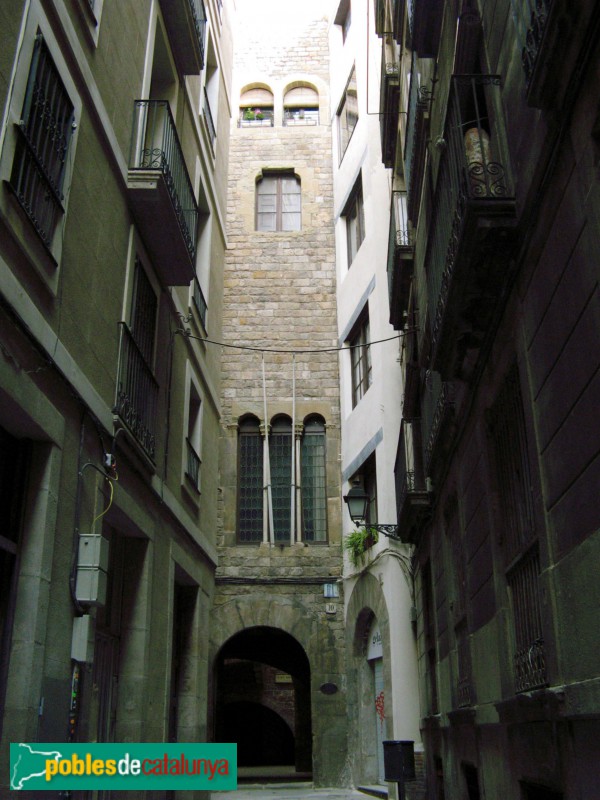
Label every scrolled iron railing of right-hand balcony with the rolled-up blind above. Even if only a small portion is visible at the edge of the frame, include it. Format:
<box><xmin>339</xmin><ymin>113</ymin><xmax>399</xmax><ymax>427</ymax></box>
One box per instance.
<box><xmin>425</xmin><ymin>75</ymin><xmax>514</xmax><ymax>356</ymax></box>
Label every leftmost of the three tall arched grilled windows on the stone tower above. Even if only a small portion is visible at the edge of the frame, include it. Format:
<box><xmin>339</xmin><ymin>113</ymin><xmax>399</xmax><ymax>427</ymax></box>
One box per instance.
<box><xmin>238</xmin><ymin>417</ymin><xmax>263</xmax><ymax>542</ymax></box>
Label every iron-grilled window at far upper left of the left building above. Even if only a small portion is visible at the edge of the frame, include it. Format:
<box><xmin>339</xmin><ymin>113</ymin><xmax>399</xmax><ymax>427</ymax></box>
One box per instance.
<box><xmin>9</xmin><ymin>31</ymin><xmax>75</xmax><ymax>248</ymax></box>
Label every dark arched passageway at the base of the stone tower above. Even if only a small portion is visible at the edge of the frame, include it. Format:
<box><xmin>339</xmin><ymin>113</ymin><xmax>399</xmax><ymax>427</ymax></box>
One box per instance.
<box><xmin>215</xmin><ymin>626</ymin><xmax>312</xmax><ymax>777</ymax></box>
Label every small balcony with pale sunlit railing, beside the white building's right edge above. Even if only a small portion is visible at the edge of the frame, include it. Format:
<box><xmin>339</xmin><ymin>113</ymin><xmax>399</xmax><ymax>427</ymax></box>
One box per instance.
<box><xmin>387</xmin><ymin>191</ymin><xmax>414</xmax><ymax>331</ymax></box>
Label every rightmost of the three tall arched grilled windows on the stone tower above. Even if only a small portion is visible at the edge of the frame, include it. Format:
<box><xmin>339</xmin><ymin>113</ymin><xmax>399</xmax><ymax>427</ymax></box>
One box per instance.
<box><xmin>301</xmin><ymin>417</ymin><xmax>327</xmax><ymax>542</ymax></box>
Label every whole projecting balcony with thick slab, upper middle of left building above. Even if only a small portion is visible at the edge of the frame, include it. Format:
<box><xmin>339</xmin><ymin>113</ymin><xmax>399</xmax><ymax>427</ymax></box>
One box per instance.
<box><xmin>127</xmin><ymin>100</ymin><xmax>198</xmax><ymax>286</ymax></box>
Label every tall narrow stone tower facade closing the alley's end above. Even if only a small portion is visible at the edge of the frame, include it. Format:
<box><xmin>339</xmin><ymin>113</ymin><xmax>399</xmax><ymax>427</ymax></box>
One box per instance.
<box><xmin>210</xmin><ymin>3</ymin><xmax>347</xmax><ymax>785</ymax></box>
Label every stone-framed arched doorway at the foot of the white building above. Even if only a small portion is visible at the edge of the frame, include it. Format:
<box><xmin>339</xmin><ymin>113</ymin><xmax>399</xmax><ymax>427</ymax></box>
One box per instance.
<box><xmin>346</xmin><ymin>572</ymin><xmax>394</xmax><ymax>785</ymax></box>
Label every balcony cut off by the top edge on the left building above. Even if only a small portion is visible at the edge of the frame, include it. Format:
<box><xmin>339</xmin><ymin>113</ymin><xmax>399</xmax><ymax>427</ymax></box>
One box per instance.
<box><xmin>160</xmin><ymin>0</ymin><xmax>206</xmax><ymax>75</ymax></box>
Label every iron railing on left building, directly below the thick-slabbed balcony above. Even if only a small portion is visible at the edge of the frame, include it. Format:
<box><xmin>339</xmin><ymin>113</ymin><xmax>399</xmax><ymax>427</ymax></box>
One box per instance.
<box><xmin>114</xmin><ymin>322</ymin><xmax>158</xmax><ymax>461</ymax></box>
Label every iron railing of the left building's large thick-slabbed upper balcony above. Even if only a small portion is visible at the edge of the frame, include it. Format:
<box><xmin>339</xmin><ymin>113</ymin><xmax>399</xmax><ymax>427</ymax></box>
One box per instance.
<box><xmin>129</xmin><ymin>100</ymin><xmax>198</xmax><ymax>259</ymax></box>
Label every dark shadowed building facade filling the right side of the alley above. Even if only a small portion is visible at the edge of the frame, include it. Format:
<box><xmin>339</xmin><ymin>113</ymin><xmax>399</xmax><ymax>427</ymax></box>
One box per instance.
<box><xmin>376</xmin><ymin>1</ymin><xmax>600</xmax><ymax>800</ymax></box>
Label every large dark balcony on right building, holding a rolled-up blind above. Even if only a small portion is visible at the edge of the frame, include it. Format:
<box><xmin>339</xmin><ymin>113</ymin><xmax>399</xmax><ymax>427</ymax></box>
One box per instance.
<box><xmin>424</xmin><ymin>75</ymin><xmax>516</xmax><ymax>379</ymax></box>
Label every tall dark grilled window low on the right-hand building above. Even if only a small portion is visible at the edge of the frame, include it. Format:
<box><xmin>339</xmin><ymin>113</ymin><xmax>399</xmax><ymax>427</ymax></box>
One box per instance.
<box><xmin>490</xmin><ymin>367</ymin><xmax>546</xmax><ymax>692</ymax></box>
